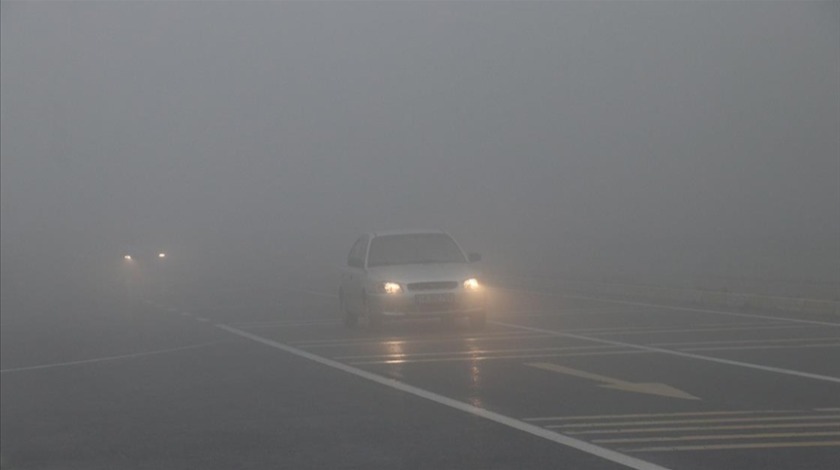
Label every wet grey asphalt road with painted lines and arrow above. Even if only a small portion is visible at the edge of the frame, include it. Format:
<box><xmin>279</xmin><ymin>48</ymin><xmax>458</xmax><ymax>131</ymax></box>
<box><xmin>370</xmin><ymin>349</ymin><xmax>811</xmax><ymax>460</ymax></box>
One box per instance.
<box><xmin>0</xmin><ymin>276</ymin><xmax>840</xmax><ymax>469</ymax></box>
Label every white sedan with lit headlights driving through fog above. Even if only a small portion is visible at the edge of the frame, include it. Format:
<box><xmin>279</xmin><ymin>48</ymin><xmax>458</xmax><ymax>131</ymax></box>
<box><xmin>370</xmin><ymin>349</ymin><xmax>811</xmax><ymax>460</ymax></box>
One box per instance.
<box><xmin>338</xmin><ymin>230</ymin><xmax>486</xmax><ymax>328</ymax></box>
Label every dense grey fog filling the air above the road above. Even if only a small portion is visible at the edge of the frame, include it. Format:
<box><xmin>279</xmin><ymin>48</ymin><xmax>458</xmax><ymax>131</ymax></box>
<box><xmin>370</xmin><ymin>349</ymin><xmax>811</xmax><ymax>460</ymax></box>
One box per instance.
<box><xmin>0</xmin><ymin>1</ymin><xmax>840</xmax><ymax>302</ymax></box>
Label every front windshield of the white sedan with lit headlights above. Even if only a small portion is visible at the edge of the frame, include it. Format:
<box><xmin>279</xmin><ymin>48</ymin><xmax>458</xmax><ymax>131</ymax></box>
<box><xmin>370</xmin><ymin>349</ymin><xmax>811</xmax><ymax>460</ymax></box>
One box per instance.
<box><xmin>368</xmin><ymin>233</ymin><xmax>466</xmax><ymax>266</ymax></box>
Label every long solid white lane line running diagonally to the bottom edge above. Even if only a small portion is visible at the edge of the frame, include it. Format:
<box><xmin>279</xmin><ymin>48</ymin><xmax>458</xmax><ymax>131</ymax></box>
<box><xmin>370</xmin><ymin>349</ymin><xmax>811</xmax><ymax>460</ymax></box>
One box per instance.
<box><xmin>216</xmin><ymin>324</ymin><xmax>667</xmax><ymax>470</ymax></box>
